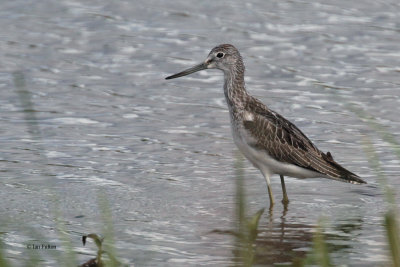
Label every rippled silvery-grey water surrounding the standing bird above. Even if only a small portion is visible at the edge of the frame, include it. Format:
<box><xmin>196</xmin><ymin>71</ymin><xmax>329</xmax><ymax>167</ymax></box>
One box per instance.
<box><xmin>0</xmin><ymin>0</ymin><xmax>400</xmax><ymax>266</ymax></box>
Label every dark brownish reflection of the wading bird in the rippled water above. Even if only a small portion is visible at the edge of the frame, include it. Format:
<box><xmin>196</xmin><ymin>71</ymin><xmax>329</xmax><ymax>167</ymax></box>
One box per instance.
<box><xmin>212</xmin><ymin>205</ymin><xmax>363</xmax><ymax>266</ymax></box>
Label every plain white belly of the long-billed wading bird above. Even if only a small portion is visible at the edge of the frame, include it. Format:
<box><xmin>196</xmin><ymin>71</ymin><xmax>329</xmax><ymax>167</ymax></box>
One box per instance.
<box><xmin>232</xmin><ymin>124</ymin><xmax>325</xmax><ymax>178</ymax></box>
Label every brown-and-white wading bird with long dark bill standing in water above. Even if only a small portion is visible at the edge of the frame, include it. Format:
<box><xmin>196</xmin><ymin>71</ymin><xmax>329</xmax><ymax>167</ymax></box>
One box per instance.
<box><xmin>165</xmin><ymin>44</ymin><xmax>366</xmax><ymax>207</ymax></box>
